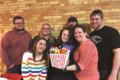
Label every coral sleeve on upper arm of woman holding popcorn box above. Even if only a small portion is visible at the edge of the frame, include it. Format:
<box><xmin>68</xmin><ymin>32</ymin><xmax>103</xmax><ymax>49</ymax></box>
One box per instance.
<box><xmin>78</xmin><ymin>43</ymin><xmax>96</xmax><ymax>70</ymax></box>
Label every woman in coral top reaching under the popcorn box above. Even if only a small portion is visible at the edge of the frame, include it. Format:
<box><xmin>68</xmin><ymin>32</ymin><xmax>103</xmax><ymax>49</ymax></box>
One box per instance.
<box><xmin>59</xmin><ymin>25</ymin><xmax>100</xmax><ymax>80</ymax></box>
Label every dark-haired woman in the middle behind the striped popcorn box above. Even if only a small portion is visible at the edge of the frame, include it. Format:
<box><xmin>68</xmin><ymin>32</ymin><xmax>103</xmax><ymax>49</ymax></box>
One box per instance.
<box><xmin>48</xmin><ymin>27</ymin><xmax>74</xmax><ymax>80</ymax></box>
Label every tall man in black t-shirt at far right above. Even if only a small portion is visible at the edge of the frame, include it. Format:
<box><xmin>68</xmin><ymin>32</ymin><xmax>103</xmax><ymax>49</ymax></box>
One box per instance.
<box><xmin>90</xmin><ymin>10</ymin><xmax>120</xmax><ymax>80</ymax></box>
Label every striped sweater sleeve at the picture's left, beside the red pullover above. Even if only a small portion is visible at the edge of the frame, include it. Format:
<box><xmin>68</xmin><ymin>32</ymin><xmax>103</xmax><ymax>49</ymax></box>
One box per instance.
<box><xmin>21</xmin><ymin>53</ymin><xmax>30</xmax><ymax>80</ymax></box>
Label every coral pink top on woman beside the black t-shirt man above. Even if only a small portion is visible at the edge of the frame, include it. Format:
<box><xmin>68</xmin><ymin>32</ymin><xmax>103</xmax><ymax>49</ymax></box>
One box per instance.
<box><xmin>74</xmin><ymin>39</ymin><xmax>100</xmax><ymax>80</ymax></box>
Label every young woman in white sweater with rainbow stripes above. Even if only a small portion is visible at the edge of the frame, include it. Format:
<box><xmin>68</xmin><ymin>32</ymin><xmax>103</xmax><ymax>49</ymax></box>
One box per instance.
<box><xmin>21</xmin><ymin>38</ymin><xmax>49</xmax><ymax>80</ymax></box>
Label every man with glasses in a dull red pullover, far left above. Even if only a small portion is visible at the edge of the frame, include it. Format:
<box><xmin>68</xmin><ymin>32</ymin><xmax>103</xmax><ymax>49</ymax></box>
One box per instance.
<box><xmin>1</xmin><ymin>16</ymin><xmax>32</xmax><ymax>74</ymax></box>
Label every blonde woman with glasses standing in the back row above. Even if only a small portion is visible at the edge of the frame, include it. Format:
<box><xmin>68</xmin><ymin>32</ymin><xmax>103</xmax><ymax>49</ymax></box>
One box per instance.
<box><xmin>29</xmin><ymin>23</ymin><xmax>56</xmax><ymax>49</ymax></box>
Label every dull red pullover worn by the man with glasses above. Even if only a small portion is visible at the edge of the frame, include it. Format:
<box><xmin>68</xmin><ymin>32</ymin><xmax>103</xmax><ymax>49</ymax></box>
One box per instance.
<box><xmin>0</xmin><ymin>29</ymin><xmax>32</xmax><ymax>67</ymax></box>
